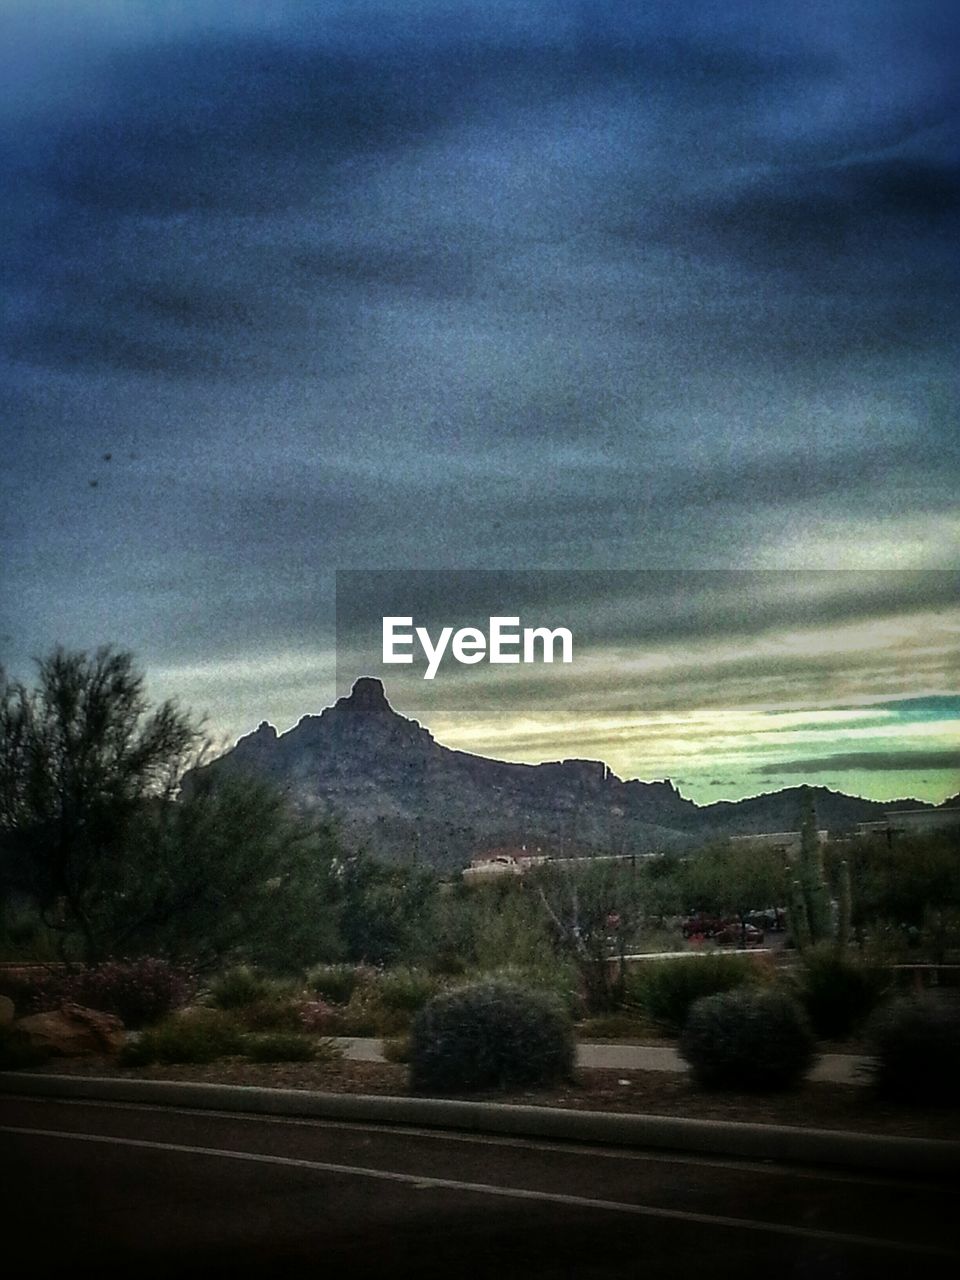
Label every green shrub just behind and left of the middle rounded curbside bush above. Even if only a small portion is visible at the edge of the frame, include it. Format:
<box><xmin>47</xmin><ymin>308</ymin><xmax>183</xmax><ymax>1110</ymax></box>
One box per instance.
<box><xmin>626</xmin><ymin>954</ymin><xmax>758</xmax><ymax>1036</ymax></box>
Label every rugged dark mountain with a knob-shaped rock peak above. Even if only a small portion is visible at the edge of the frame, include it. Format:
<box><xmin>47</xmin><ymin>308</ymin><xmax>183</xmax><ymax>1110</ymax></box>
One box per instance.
<box><xmin>192</xmin><ymin>677</ymin><xmax>916</xmax><ymax>868</ymax></box>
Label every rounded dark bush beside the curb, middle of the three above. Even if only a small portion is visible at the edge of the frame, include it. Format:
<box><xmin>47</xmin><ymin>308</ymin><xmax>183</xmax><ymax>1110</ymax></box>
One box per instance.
<box><xmin>680</xmin><ymin>988</ymin><xmax>815</xmax><ymax>1092</ymax></box>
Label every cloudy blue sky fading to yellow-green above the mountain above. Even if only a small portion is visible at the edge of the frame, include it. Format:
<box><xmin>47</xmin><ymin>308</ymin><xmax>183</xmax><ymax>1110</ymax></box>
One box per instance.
<box><xmin>0</xmin><ymin>0</ymin><xmax>960</xmax><ymax>801</ymax></box>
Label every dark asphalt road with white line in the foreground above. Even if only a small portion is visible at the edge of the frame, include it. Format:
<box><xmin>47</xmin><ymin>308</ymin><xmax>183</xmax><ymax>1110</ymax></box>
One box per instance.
<box><xmin>0</xmin><ymin>1097</ymin><xmax>960</xmax><ymax>1280</ymax></box>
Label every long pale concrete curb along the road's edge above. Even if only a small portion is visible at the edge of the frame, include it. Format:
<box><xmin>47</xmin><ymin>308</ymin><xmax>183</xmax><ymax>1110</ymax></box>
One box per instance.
<box><xmin>0</xmin><ymin>1071</ymin><xmax>960</xmax><ymax>1178</ymax></box>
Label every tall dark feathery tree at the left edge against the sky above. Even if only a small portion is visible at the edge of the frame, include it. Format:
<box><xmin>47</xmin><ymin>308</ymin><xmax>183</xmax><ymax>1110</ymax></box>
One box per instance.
<box><xmin>0</xmin><ymin>648</ymin><xmax>200</xmax><ymax>960</ymax></box>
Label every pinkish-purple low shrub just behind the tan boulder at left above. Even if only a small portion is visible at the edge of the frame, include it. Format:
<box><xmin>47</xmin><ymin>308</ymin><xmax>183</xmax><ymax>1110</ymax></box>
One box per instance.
<box><xmin>32</xmin><ymin>956</ymin><xmax>196</xmax><ymax>1028</ymax></box>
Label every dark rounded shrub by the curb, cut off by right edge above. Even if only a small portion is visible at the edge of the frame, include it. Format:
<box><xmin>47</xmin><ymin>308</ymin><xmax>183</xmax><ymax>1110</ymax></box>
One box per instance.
<box><xmin>868</xmin><ymin>997</ymin><xmax>960</xmax><ymax>1106</ymax></box>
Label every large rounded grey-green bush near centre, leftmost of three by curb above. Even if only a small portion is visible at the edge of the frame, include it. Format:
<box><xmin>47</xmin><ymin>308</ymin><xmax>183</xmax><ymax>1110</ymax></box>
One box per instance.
<box><xmin>410</xmin><ymin>982</ymin><xmax>573</xmax><ymax>1089</ymax></box>
